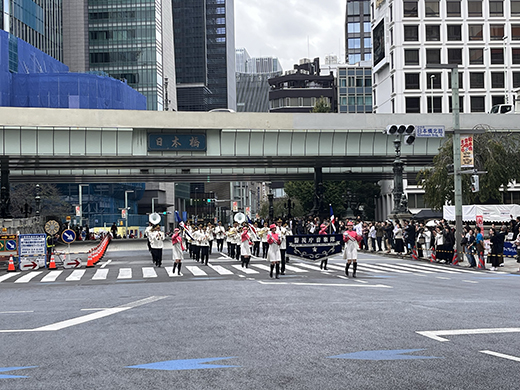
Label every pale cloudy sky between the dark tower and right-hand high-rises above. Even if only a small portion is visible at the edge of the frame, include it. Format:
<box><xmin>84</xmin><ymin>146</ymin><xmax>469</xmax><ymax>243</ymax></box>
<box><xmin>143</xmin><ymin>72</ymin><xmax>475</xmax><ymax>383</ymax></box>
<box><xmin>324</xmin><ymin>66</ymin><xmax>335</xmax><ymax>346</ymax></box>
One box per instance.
<box><xmin>235</xmin><ymin>0</ymin><xmax>346</xmax><ymax>70</ymax></box>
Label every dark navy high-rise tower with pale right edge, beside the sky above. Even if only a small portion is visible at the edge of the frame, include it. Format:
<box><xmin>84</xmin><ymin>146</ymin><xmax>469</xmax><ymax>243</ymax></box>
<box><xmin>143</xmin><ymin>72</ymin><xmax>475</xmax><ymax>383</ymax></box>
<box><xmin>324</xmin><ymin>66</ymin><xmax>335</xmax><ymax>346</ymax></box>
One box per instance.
<box><xmin>172</xmin><ymin>0</ymin><xmax>236</xmax><ymax>111</ymax></box>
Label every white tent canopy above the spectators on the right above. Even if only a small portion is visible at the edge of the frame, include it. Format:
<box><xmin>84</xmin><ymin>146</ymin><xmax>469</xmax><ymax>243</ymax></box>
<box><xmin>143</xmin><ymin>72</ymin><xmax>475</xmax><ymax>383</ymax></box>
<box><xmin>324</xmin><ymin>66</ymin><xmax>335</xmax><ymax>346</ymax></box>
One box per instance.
<box><xmin>443</xmin><ymin>204</ymin><xmax>520</xmax><ymax>222</ymax></box>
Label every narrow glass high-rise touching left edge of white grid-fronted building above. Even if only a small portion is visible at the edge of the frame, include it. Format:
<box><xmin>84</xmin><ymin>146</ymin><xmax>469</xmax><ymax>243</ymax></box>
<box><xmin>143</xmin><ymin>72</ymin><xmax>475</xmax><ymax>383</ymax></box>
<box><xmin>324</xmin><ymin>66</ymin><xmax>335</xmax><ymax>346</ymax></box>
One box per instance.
<box><xmin>345</xmin><ymin>0</ymin><xmax>372</xmax><ymax>65</ymax></box>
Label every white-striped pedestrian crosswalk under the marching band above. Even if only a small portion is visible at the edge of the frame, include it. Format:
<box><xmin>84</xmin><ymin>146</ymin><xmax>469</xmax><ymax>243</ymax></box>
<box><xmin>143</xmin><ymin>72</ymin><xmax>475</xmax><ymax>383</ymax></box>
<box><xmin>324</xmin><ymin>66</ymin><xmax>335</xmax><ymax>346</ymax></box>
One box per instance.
<box><xmin>0</xmin><ymin>260</ymin><xmax>492</xmax><ymax>284</ymax></box>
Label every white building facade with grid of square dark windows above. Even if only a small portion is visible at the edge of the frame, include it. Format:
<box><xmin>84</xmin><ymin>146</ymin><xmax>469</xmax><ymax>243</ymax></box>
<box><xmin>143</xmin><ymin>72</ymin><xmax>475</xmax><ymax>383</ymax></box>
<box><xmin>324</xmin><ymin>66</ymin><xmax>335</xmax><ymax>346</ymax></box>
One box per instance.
<box><xmin>371</xmin><ymin>0</ymin><xmax>520</xmax><ymax>113</ymax></box>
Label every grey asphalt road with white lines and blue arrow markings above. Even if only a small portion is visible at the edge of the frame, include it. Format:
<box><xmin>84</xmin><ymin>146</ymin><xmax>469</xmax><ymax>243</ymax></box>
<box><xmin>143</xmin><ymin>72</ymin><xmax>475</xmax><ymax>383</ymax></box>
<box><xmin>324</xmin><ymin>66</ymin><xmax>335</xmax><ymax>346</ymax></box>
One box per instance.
<box><xmin>0</xmin><ymin>242</ymin><xmax>520</xmax><ymax>390</ymax></box>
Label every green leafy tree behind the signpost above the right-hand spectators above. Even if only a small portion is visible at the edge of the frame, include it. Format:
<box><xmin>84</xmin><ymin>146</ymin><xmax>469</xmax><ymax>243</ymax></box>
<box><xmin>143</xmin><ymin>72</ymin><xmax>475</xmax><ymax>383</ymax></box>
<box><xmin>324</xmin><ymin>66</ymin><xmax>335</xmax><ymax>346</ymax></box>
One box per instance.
<box><xmin>417</xmin><ymin>131</ymin><xmax>520</xmax><ymax>210</ymax></box>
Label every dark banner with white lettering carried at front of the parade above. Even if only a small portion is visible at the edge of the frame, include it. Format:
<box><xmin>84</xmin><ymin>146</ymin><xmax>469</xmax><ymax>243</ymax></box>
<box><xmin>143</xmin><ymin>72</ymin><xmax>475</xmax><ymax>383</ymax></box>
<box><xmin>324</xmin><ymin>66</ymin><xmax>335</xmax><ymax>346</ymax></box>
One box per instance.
<box><xmin>286</xmin><ymin>234</ymin><xmax>343</xmax><ymax>261</ymax></box>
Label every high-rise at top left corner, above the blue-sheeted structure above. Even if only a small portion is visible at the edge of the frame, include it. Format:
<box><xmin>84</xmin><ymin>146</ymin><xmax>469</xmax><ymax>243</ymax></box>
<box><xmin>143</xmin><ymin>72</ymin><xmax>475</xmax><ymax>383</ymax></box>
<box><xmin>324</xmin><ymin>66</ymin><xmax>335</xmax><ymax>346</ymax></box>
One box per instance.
<box><xmin>0</xmin><ymin>0</ymin><xmax>63</xmax><ymax>61</ymax></box>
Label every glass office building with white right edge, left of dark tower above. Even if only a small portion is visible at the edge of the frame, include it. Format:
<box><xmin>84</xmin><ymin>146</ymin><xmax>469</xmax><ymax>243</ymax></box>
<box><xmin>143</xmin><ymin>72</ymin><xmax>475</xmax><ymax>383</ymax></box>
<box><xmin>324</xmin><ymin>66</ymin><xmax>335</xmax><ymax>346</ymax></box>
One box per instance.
<box><xmin>88</xmin><ymin>0</ymin><xmax>177</xmax><ymax>110</ymax></box>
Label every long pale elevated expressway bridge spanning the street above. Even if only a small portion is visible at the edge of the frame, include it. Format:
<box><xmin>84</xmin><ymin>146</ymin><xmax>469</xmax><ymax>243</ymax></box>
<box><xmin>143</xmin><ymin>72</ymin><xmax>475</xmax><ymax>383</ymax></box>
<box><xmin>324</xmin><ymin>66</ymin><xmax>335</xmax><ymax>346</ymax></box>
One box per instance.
<box><xmin>0</xmin><ymin>108</ymin><xmax>520</xmax><ymax>185</ymax></box>
